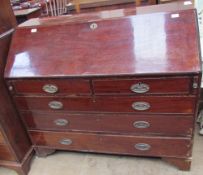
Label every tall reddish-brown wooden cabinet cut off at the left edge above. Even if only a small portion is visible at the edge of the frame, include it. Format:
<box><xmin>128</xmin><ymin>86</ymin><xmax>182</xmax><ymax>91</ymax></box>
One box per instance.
<box><xmin>0</xmin><ymin>0</ymin><xmax>32</xmax><ymax>175</ymax></box>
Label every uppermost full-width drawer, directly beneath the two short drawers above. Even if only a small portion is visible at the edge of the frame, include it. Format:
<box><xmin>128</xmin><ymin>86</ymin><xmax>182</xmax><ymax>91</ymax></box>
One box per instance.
<box><xmin>15</xmin><ymin>96</ymin><xmax>195</xmax><ymax>114</ymax></box>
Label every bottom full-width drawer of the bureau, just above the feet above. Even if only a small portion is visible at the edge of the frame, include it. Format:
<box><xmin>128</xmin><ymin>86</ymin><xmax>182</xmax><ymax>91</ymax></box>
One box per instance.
<box><xmin>29</xmin><ymin>131</ymin><xmax>192</xmax><ymax>157</ymax></box>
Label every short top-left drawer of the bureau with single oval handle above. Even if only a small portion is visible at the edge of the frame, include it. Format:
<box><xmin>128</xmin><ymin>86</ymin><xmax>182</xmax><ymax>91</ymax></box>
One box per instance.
<box><xmin>8</xmin><ymin>79</ymin><xmax>91</xmax><ymax>95</ymax></box>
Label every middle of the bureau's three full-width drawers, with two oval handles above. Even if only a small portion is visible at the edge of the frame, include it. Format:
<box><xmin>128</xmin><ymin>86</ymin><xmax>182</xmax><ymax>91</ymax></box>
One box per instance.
<box><xmin>21</xmin><ymin>112</ymin><xmax>193</xmax><ymax>136</ymax></box>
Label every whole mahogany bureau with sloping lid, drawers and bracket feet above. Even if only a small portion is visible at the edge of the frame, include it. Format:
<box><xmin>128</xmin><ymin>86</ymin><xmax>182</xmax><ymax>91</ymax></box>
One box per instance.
<box><xmin>5</xmin><ymin>1</ymin><xmax>201</xmax><ymax>170</ymax></box>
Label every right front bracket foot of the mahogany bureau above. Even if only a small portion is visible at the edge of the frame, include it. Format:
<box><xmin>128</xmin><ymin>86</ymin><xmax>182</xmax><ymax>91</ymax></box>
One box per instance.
<box><xmin>162</xmin><ymin>157</ymin><xmax>192</xmax><ymax>171</ymax></box>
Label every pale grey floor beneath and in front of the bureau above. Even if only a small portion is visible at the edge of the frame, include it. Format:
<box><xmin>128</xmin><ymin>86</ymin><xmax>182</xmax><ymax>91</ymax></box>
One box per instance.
<box><xmin>0</xmin><ymin>127</ymin><xmax>203</xmax><ymax>175</ymax></box>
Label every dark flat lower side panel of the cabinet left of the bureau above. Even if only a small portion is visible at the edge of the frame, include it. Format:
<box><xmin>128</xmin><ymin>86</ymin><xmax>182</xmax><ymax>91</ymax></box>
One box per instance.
<box><xmin>0</xmin><ymin>36</ymin><xmax>31</xmax><ymax>161</ymax></box>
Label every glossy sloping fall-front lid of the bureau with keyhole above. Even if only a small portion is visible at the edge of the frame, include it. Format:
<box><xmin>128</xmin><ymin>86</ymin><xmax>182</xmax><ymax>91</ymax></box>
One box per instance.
<box><xmin>5</xmin><ymin>5</ymin><xmax>201</xmax><ymax>78</ymax></box>
